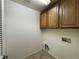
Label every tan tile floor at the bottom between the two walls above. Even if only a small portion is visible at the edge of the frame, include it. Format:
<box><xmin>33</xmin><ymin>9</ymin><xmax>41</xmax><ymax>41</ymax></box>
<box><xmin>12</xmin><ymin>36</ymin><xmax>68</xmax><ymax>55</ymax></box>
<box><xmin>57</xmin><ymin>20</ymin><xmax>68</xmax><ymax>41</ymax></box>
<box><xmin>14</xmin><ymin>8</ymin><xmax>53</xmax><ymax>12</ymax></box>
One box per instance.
<box><xmin>25</xmin><ymin>51</ymin><xmax>55</xmax><ymax>59</ymax></box>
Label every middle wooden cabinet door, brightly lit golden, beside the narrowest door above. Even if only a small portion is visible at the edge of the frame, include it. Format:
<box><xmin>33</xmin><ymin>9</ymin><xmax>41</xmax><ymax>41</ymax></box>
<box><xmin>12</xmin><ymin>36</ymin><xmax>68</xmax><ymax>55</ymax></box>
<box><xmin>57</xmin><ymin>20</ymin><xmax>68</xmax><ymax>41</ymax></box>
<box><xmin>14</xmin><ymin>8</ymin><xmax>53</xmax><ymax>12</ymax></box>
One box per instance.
<box><xmin>48</xmin><ymin>5</ymin><xmax>58</xmax><ymax>28</ymax></box>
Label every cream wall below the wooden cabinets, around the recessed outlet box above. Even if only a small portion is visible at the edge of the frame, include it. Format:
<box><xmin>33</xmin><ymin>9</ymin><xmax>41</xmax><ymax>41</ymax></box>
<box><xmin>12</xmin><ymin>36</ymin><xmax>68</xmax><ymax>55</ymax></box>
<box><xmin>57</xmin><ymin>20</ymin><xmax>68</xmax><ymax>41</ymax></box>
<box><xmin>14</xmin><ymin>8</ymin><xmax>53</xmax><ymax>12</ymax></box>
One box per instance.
<box><xmin>43</xmin><ymin>29</ymin><xmax>79</xmax><ymax>59</ymax></box>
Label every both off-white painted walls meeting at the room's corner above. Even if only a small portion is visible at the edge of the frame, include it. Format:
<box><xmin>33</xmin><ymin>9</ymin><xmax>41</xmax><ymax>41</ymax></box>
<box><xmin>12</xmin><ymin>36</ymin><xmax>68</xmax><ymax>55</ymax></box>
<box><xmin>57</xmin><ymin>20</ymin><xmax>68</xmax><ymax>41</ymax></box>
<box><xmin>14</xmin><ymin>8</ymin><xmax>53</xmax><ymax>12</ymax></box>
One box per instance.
<box><xmin>3</xmin><ymin>0</ymin><xmax>79</xmax><ymax>59</ymax></box>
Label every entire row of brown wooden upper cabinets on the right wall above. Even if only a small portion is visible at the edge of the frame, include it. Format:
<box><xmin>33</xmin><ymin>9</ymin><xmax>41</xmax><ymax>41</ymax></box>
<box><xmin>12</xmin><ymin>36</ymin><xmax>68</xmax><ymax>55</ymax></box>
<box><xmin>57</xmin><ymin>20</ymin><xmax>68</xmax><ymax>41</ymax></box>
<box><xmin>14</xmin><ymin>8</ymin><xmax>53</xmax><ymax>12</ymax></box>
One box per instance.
<box><xmin>41</xmin><ymin>0</ymin><xmax>79</xmax><ymax>28</ymax></box>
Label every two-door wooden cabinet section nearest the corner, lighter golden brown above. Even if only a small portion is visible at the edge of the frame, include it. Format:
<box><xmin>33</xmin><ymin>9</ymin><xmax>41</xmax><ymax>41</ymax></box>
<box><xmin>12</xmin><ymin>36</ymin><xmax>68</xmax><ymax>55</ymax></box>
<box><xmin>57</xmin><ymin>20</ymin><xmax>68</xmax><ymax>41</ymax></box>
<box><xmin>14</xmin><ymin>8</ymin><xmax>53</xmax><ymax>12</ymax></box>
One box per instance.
<box><xmin>40</xmin><ymin>5</ymin><xmax>58</xmax><ymax>28</ymax></box>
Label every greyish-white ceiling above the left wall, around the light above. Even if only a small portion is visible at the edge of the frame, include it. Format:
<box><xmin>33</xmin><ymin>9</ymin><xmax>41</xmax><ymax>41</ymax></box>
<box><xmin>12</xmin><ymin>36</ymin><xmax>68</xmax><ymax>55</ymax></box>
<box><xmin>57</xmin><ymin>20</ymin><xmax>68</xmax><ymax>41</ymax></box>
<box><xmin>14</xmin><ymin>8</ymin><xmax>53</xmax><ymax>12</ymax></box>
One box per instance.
<box><xmin>12</xmin><ymin>0</ymin><xmax>56</xmax><ymax>11</ymax></box>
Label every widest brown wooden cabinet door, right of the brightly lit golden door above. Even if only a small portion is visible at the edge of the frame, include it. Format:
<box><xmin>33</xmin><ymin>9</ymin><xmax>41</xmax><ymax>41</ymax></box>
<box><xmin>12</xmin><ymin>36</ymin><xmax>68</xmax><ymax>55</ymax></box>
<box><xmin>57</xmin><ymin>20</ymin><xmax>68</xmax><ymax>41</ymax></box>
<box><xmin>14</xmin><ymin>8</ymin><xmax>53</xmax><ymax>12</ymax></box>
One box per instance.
<box><xmin>60</xmin><ymin>0</ymin><xmax>76</xmax><ymax>27</ymax></box>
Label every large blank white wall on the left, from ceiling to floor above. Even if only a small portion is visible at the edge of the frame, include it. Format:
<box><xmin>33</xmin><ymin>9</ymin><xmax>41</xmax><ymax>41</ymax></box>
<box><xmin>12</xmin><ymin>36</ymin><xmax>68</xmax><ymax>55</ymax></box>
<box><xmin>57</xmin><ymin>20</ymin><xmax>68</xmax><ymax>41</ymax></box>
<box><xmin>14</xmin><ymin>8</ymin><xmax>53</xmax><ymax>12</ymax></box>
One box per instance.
<box><xmin>4</xmin><ymin>0</ymin><xmax>42</xmax><ymax>59</ymax></box>
